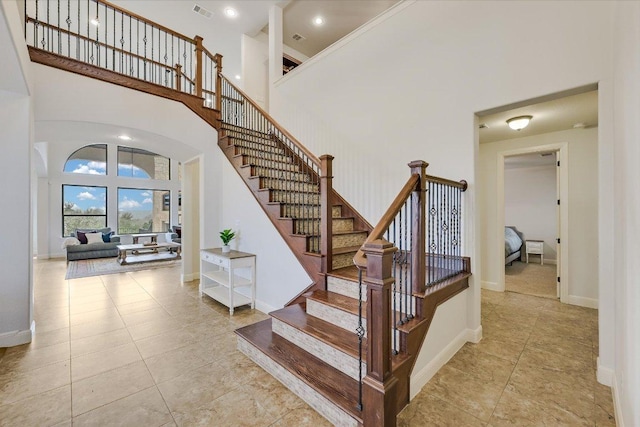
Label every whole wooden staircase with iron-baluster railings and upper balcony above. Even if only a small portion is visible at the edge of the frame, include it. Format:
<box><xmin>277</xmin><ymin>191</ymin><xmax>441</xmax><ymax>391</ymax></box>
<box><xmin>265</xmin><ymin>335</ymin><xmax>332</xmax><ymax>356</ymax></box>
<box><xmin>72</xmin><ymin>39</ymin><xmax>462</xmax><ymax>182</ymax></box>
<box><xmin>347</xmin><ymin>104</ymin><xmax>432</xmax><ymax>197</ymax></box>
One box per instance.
<box><xmin>25</xmin><ymin>0</ymin><xmax>470</xmax><ymax>426</ymax></box>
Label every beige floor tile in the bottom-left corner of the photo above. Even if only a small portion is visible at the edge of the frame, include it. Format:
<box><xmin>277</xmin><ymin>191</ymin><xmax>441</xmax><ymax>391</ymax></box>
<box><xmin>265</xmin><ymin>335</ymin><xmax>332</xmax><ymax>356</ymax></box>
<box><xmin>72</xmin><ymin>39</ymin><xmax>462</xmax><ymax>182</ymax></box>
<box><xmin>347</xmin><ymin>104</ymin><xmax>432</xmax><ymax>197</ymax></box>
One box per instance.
<box><xmin>0</xmin><ymin>385</ymin><xmax>71</xmax><ymax>427</ymax></box>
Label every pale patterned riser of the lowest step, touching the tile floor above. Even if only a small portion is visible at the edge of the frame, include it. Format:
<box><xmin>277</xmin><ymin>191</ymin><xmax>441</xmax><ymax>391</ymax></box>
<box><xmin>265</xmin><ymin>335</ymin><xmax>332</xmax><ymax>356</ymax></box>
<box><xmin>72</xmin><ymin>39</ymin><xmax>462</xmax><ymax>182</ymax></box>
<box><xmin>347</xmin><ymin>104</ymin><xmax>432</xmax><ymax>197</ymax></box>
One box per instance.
<box><xmin>238</xmin><ymin>337</ymin><xmax>358</xmax><ymax>427</ymax></box>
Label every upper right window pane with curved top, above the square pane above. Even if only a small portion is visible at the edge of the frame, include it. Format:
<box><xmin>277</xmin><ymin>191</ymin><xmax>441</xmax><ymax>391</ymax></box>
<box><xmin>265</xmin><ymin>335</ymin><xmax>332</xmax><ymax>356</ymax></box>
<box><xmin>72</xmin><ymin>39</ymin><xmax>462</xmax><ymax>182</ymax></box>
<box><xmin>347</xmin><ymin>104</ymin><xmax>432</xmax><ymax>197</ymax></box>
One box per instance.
<box><xmin>118</xmin><ymin>147</ymin><xmax>170</xmax><ymax>180</ymax></box>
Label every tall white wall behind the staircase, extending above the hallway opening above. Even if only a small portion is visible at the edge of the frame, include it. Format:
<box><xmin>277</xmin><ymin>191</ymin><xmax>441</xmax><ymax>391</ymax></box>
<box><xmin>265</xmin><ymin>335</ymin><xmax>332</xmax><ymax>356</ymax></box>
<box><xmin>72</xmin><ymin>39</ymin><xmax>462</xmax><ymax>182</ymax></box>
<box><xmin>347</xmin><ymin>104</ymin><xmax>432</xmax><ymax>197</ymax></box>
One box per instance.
<box><xmin>270</xmin><ymin>1</ymin><xmax>614</xmax><ymax>392</ymax></box>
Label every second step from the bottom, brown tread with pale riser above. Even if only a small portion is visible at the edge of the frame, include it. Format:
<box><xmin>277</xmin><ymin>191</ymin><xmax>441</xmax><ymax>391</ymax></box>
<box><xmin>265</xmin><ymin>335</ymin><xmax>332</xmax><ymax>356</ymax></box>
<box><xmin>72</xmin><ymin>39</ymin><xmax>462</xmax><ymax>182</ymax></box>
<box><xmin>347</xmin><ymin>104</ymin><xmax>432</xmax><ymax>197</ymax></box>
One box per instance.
<box><xmin>269</xmin><ymin>304</ymin><xmax>367</xmax><ymax>380</ymax></box>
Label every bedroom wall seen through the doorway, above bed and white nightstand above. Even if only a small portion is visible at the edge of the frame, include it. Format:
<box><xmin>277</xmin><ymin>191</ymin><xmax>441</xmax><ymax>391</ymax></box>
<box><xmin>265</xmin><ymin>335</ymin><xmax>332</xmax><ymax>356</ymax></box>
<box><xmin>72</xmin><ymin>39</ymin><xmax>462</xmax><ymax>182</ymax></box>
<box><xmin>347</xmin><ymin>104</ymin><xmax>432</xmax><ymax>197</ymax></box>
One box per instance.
<box><xmin>504</xmin><ymin>165</ymin><xmax>558</xmax><ymax>264</ymax></box>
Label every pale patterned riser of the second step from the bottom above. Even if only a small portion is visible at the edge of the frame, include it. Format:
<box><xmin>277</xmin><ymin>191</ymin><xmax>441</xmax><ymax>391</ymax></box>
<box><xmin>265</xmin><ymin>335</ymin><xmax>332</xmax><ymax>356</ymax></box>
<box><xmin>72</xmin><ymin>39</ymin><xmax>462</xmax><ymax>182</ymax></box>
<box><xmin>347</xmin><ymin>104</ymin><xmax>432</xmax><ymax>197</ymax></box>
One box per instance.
<box><xmin>272</xmin><ymin>318</ymin><xmax>367</xmax><ymax>380</ymax></box>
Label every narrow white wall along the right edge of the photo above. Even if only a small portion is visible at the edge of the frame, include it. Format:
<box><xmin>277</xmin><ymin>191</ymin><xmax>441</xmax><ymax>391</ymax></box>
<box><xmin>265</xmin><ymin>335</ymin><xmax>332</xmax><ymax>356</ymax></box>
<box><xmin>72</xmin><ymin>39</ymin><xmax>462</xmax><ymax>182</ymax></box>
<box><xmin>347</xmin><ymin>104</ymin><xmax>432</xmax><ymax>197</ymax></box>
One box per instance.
<box><xmin>598</xmin><ymin>2</ymin><xmax>640</xmax><ymax>427</ymax></box>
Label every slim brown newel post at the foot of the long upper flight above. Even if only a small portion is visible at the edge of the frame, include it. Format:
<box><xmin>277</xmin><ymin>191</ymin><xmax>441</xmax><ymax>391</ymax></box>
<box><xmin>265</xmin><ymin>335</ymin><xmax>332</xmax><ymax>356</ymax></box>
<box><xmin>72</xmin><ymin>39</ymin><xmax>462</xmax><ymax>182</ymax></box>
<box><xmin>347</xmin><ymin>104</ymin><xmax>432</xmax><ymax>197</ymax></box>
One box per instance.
<box><xmin>320</xmin><ymin>154</ymin><xmax>334</xmax><ymax>273</ymax></box>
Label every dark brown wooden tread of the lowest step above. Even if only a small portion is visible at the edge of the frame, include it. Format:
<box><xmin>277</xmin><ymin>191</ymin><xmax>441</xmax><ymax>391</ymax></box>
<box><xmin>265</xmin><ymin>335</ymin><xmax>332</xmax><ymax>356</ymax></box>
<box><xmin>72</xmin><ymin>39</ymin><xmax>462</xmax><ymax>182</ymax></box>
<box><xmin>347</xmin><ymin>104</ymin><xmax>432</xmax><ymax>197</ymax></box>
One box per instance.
<box><xmin>235</xmin><ymin>319</ymin><xmax>362</xmax><ymax>423</ymax></box>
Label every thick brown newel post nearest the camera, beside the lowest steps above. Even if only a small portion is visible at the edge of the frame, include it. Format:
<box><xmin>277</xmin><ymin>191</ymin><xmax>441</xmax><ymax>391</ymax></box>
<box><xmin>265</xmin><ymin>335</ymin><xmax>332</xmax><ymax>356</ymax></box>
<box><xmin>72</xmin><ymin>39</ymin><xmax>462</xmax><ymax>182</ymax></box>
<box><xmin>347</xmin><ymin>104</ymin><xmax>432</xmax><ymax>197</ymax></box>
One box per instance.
<box><xmin>362</xmin><ymin>239</ymin><xmax>398</xmax><ymax>427</ymax></box>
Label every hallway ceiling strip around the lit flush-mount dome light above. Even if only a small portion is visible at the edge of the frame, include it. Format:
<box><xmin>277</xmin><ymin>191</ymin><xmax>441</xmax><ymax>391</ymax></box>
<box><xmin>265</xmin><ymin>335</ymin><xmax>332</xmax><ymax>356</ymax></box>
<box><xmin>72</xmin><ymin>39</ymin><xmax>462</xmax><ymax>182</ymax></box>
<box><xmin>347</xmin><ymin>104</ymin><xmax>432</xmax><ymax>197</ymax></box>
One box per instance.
<box><xmin>478</xmin><ymin>90</ymin><xmax>598</xmax><ymax>144</ymax></box>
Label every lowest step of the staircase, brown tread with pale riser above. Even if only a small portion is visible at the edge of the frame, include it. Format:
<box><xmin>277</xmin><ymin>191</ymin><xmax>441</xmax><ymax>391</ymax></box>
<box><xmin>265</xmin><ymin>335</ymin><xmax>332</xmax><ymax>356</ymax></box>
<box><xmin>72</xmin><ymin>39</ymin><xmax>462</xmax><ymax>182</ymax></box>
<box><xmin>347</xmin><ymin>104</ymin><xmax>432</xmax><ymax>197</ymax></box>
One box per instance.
<box><xmin>236</xmin><ymin>319</ymin><xmax>363</xmax><ymax>427</ymax></box>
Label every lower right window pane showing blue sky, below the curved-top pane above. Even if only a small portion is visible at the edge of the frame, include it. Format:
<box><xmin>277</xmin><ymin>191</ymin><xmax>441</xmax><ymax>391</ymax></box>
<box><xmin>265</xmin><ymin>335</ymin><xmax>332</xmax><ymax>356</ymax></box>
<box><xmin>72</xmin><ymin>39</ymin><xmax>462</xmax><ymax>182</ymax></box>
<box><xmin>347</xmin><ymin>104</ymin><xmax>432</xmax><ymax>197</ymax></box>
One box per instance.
<box><xmin>118</xmin><ymin>188</ymin><xmax>171</xmax><ymax>234</ymax></box>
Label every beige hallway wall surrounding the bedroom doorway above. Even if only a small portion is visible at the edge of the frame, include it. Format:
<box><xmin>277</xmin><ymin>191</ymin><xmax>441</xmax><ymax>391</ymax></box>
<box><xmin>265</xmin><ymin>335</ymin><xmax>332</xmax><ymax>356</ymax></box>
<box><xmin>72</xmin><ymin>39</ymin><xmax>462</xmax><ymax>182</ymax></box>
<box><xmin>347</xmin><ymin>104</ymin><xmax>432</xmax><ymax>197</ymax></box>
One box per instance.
<box><xmin>479</xmin><ymin>129</ymin><xmax>598</xmax><ymax>307</ymax></box>
